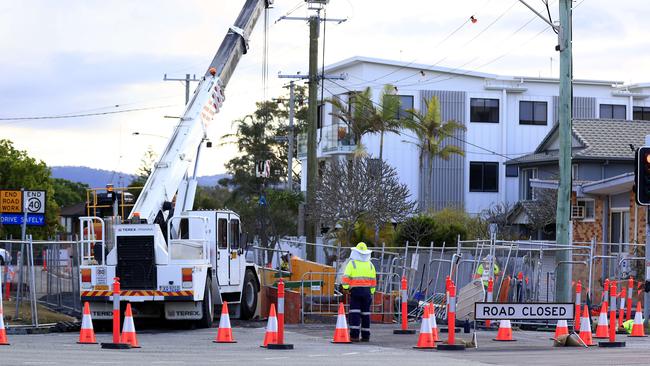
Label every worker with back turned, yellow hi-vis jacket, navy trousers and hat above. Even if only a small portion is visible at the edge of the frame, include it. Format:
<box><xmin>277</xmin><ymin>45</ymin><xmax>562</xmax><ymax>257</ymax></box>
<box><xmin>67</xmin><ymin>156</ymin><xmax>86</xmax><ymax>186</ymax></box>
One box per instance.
<box><xmin>341</xmin><ymin>243</ymin><xmax>377</xmax><ymax>342</ymax></box>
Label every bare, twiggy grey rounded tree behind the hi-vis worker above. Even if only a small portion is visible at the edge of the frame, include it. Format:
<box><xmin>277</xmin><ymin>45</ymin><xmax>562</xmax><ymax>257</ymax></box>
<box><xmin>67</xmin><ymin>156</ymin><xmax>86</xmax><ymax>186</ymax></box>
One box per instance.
<box><xmin>311</xmin><ymin>158</ymin><xmax>415</xmax><ymax>245</ymax></box>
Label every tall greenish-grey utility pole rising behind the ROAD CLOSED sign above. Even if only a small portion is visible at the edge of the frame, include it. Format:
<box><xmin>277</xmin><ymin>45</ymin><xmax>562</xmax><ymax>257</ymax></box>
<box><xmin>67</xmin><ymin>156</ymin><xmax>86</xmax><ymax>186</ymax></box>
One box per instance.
<box><xmin>519</xmin><ymin>0</ymin><xmax>573</xmax><ymax>302</ymax></box>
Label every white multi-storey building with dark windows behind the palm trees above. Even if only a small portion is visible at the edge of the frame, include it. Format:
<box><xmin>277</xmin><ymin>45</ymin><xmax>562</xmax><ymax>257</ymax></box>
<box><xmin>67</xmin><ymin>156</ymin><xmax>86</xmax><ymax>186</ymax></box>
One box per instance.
<box><xmin>298</xmin><ymin>57</ymin><xmax>650</xmax><ymax>214</ymax></box>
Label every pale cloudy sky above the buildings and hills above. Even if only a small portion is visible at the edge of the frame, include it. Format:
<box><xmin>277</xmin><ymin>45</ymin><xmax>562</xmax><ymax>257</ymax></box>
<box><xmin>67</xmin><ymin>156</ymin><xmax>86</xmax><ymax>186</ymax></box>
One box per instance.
<box><xmin>0</xmin><ymin>0</ymin><xmax>650</xmax><ymax>180</ymax></box>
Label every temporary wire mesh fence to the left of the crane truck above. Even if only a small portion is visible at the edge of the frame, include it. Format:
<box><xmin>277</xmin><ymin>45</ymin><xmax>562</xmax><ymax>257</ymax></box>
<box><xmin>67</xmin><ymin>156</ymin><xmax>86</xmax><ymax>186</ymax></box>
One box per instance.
<box><xmin>0</xmin><ymin>239</ymin><xmax>81</xmax><ymax>327</ymax></box>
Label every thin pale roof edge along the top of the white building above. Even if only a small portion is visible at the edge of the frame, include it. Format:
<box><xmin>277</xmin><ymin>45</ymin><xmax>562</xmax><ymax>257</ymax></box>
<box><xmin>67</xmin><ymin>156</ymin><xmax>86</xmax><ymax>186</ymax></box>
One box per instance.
<box><xmin>325</xmin><ymin>56</ymin><xmax>623</xmax><ymax>86</ymax></box>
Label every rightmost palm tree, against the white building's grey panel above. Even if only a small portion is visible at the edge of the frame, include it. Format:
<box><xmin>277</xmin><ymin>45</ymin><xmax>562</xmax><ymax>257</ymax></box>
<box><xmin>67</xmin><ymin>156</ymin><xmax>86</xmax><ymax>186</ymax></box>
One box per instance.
<box><xmin>403</xmin><ymin>97</ymin><xmax>465</xmax><ymax>210</ymax></box>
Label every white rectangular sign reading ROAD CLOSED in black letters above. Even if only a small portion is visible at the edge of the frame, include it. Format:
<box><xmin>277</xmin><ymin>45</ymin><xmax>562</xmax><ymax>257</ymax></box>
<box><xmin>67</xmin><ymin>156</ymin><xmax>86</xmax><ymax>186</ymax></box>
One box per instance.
<box><xmin>474</xmin><ymin>302</ymin><xmax>575</xmax><ymax>320</ymax></box>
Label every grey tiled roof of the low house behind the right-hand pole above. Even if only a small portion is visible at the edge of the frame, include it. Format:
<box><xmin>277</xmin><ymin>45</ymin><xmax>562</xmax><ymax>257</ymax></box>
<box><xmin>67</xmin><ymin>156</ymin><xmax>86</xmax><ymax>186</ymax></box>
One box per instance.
<box><xmin>506</xmin><ymin>119</ymin><xmax>650</xmax><ymax>165</ymax></box>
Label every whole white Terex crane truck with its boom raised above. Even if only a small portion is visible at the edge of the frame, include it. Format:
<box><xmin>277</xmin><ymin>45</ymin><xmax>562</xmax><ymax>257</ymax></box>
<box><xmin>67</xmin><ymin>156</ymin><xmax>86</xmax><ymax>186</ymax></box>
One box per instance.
<box><xmin>79</xmin><ymin>0</ymin><xmax>273</xmax><ymax>327</ymax></box>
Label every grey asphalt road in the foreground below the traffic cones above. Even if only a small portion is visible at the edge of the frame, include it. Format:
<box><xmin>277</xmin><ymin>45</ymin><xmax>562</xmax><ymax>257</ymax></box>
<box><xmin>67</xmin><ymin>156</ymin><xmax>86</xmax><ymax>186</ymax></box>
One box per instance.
<box><xmin>0</xmin><ymin>322</ymin><xmax>650</xmax><ymax>366</ymax></box>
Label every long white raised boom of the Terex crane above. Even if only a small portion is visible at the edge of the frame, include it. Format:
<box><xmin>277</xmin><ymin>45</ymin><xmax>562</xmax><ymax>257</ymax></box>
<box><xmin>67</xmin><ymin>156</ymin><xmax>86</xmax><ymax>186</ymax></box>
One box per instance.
<box><xmin>129</xmin><ymin>0</ymin><xmax>273</xmax><ymax>223</ymax></box>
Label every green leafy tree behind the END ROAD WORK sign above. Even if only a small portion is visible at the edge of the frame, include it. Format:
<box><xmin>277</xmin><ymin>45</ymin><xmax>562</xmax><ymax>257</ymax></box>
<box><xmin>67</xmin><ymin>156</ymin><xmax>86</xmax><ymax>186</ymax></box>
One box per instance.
<box><xmin>0</xmin><ymin>140</ymin><xmax>59</xmax><ymax>238</ymax></box>
